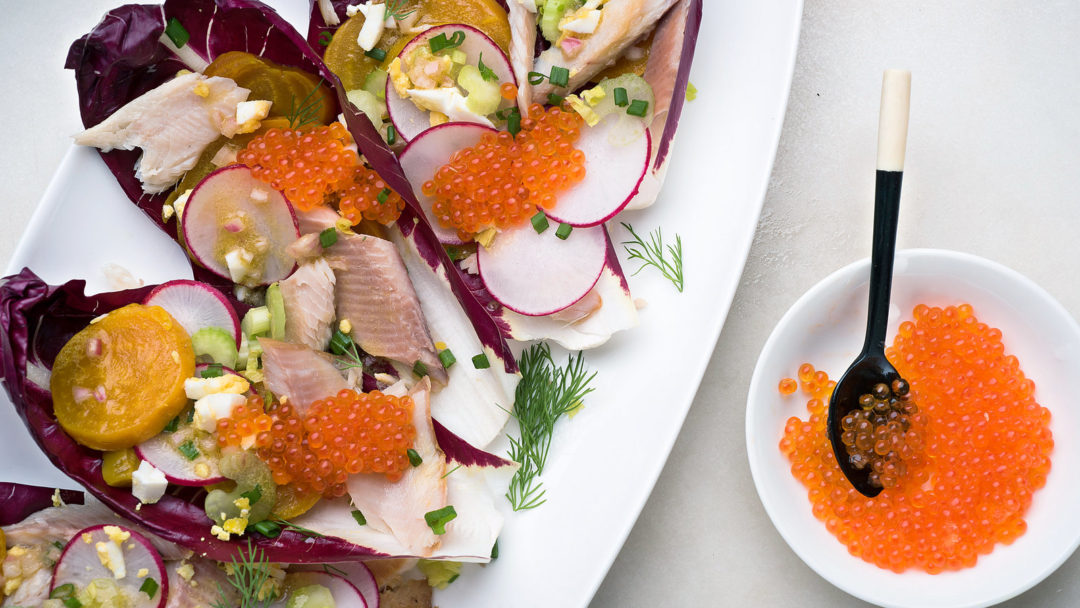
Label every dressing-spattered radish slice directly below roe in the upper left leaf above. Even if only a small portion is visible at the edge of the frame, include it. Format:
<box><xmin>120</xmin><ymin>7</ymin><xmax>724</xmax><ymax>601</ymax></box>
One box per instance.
<box><xmin>183</xmin><ymin>165</ymin><xmax>300</xmax><ymax>286</ymax></box>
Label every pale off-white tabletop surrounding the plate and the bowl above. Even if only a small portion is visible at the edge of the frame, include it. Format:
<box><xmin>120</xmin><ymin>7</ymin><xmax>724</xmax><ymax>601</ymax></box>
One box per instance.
<box><xmin>0</xmin><ymin>0</ymin><xmax>1080</xmax><ymax>608</ymax></box>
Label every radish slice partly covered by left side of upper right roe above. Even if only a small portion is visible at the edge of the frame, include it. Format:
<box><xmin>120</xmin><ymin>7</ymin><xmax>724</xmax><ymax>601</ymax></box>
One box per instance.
<box><xmin>401</xmin><ymin>122</ymin><xmax>498</xmax><ymax>245</ymax></box>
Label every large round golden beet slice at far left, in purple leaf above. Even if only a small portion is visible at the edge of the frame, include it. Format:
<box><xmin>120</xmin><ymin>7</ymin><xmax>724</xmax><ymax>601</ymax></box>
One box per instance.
<box><xmin>50</xmin><ymin>305</ymin><xmax>195</xmax><ymax>450</ymax></box>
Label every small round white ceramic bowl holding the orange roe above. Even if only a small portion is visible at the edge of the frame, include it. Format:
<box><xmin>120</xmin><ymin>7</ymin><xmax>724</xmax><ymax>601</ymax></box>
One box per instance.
<box><xmin>746</xmin><ymin>249</ymin><xmax>1080</xmax><ymax>608</ymax></box>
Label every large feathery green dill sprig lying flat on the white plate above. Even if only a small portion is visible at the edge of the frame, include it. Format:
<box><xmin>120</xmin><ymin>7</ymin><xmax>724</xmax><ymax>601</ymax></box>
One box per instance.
<box><xmin>507</xmin><ymin>342</ymin><xmax>596</xmax><ymax>511</ymax></box>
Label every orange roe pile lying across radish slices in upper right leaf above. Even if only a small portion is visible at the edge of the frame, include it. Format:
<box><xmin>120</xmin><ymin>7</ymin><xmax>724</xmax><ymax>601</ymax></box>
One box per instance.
<box><xmin>421</xmin><ymin>104</ymin><xmax>585</xmax><ymax>240</ymax></box>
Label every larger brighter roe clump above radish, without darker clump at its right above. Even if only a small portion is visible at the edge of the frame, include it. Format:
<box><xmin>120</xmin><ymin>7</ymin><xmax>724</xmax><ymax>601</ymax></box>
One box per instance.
<box><xmin>237</xmin><ymin>122</ymin><xmax>359</xmax><ymax>211</ymax></box>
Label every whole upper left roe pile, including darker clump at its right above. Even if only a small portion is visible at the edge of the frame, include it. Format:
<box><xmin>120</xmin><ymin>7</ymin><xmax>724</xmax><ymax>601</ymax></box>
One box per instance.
<box><xmin>237</xmin><ymin>122</ymin><xmax>405</xmax><ymax>226</ymax></box>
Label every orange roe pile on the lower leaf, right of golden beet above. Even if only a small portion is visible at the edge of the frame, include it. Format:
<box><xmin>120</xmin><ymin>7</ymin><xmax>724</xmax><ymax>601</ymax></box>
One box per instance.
<box><xmin>217</xmin><ymin>390</ymin><xmax>416</xmax><ymax>498</ymax></box>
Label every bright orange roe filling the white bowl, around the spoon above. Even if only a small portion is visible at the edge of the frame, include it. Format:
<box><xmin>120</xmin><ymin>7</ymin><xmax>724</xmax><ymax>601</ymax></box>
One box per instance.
<box><xmin>780</xmin><ymin>305</ymin><xmax>1054</xmax><ymax>573</ymax></box>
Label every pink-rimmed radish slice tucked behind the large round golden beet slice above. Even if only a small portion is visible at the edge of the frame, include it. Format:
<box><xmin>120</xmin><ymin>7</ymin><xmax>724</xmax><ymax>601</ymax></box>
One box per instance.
<box><xmin>143</xmin><ymin>279</ymin><xmax>240</xmax><ymax>348</ymax></box>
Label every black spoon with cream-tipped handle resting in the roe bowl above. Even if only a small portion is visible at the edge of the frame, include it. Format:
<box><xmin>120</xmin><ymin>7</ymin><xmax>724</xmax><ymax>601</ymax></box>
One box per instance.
<box><xmin>828</xmin><ymin>70</ymin><xmax>912</xmax><ymax>497</ymax></box>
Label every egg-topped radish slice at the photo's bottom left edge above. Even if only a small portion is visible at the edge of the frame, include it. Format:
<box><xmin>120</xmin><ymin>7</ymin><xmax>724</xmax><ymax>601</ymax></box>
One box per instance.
<box><xmin>50</xmin><ymin>525</ymin><xmax>168</xmax><ymax>608</ymax></box>
